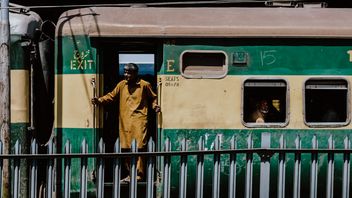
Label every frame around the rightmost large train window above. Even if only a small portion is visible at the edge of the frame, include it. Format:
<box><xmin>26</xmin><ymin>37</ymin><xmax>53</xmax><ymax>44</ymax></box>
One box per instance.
<box><xmin>302</xmin><ymin>77</ymin><xmax>351</xmax><ymax>128</ymax></box>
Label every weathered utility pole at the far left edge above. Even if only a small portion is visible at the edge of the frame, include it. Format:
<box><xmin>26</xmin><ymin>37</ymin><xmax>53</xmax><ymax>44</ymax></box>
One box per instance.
<box><xmin>0</xmin><ymin>0</ymin><xmax>11</xmax><ymax>197</ymax></box>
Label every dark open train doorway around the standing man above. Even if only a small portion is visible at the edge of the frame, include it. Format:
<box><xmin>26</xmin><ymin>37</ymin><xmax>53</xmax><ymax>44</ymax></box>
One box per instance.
<box><xmin>99</xmin><ymin>41</ymin><xmax>157</xmax><ymax>189</ymax></box>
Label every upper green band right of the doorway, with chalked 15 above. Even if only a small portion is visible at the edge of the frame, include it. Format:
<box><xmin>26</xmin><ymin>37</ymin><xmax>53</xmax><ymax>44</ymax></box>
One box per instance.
<box><xmin>160</xmin><ymin>39</ymin><xmax>352</xmax><ymax>75</ymax></box>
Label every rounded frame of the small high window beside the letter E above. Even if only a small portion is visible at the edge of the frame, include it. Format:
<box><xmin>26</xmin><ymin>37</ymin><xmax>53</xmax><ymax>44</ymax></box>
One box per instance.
<box><xmin>179</xmin><ymin>50</ymin><xmax>229</xmax><ymax>79</ymax></box>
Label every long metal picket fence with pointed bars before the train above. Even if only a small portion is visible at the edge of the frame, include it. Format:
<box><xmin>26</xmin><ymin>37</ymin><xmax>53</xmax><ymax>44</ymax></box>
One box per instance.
<box><xmin>0</xmin><ymin>133</ymin><xmax>351</xmax><ymax>198</ymax></box>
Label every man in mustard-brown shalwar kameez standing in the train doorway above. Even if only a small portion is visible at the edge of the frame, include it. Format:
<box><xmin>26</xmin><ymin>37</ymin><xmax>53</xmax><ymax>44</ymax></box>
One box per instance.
<box><xmin>92</xmin><ymin>63</ymin><xmax>160</xmax><ymax>182</ymax></box>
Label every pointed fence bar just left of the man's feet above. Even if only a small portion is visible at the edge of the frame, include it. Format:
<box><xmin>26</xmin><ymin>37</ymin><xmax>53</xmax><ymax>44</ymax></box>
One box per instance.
<box><xmin>113</xmin><ymin>138</ymin><xmax>121</xmax><ymax>198</ymax></box>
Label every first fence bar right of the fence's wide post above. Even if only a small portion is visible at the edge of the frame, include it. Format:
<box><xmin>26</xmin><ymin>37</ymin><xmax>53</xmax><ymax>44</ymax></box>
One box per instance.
<box><xmin>277</xmin><ymin>135</ymin><xmax>286</xmax><ymax>198</ymax></box>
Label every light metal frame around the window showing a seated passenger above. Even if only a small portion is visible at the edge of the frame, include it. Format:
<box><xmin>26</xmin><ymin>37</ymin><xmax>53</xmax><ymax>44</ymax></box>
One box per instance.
<box><xmin>241</xmin><ymin>77</ymin><xmax>290</xmax><ymax>128</ymax></box>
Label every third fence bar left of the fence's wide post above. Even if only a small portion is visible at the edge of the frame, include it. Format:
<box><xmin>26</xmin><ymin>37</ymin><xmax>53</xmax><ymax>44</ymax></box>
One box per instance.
<box><xmin>212</xmin><ymin>135</ymin><xmax>221</xmax><ymax>198</ymax></box>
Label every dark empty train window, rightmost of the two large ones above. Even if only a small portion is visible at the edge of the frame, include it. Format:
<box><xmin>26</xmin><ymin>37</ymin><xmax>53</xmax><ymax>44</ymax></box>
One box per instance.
<box><xmin>304</xmin><ymin>79</ymin><xmax>349</xmax><ymax>127</ymax></box>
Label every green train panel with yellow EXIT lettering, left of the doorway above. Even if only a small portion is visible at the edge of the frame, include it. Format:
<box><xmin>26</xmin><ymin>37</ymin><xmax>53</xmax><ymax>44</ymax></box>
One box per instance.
<box><xmin>55</xmin><ymin>35</ymin><xmax>97</xmax><ymax>74</ymax></box>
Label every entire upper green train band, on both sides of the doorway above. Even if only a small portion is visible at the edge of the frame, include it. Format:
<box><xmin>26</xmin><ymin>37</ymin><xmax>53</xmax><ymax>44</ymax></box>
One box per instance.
<box><xmin>55</xmin><ymin>35</ymin><xmax>352</xmax><ymax>75</ymax></box>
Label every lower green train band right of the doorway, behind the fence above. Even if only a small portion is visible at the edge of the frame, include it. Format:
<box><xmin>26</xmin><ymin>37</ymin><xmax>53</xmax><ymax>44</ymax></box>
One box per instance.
<box><xmin>159</xmin><ymin>129</ymin><xmax>351</xmax><ymax>197</ymax></box>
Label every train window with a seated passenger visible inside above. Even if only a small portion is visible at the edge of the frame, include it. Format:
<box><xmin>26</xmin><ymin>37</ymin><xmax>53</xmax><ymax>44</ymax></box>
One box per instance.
<box><xmin>242</xmin><ymin>79</ymin><xmax>289</xmax><ymax>127</ymax></box>
